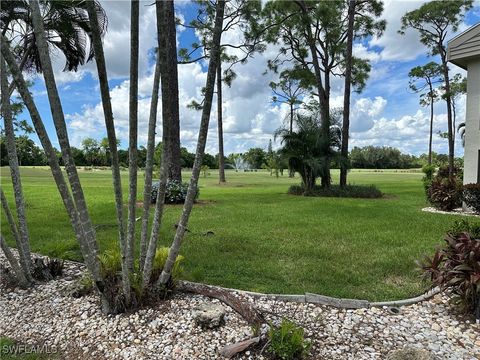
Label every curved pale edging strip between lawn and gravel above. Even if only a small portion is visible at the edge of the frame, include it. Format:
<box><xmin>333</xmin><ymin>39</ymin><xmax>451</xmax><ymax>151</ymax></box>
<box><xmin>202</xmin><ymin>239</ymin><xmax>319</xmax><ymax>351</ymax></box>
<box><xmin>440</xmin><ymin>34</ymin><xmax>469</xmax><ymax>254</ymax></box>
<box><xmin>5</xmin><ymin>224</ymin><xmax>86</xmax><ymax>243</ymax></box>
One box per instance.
<box><xmin>180</xmin><ymin>280</ymin><xmax>440</xmax><ymax>309</ymax></box>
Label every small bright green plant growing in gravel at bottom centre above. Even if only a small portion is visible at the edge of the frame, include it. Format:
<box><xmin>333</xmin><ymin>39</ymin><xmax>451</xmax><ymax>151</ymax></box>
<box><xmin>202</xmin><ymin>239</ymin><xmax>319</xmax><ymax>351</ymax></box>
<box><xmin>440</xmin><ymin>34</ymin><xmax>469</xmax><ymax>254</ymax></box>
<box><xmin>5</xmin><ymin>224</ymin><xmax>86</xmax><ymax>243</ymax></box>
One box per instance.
<box><xmin>268</xmin><ymin>319</ymin><xmax>311</xmax><ymax>360</ymax></box>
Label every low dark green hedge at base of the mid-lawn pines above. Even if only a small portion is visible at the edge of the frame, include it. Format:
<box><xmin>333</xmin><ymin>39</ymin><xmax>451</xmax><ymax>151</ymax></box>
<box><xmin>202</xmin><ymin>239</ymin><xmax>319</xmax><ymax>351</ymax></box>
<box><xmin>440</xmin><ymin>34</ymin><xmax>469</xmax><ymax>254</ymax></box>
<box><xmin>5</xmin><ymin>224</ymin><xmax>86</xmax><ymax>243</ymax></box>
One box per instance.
<box><xmin>288</xmin><ymin>185</ymin><xmax>383</xmax><ymax>199</ymax></box>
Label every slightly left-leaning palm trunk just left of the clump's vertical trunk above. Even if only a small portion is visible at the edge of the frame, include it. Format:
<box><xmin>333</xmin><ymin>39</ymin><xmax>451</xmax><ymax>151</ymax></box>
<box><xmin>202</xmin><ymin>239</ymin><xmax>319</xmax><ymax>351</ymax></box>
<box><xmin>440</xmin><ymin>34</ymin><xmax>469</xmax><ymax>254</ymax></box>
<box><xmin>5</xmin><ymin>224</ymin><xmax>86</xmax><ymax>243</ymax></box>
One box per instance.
<box><xmin>87</xmin><ymin>1</ymin><xmax>130</xmax><ymax>299</ymax></box>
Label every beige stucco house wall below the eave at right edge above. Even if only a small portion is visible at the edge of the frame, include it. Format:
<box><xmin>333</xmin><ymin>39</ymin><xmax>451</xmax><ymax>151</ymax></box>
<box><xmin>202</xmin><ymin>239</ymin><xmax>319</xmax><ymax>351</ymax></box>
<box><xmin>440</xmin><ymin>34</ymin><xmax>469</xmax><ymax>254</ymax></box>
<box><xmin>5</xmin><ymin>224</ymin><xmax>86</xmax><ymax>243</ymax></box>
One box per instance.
<box><xmin>463</xmin><ymin>58</ymin><xmax>480</xmax><ymax>184</ymax></box>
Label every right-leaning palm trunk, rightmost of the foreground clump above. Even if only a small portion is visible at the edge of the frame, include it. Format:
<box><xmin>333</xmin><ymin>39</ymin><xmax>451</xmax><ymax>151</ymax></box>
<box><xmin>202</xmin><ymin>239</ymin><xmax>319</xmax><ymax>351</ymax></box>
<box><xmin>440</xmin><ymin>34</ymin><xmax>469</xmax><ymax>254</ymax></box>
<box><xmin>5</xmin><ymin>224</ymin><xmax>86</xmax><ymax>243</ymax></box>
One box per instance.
<box><xmin>158</xmin><ymin>0</ymin><xmax>225</xmax><ymax>285</ymax></box>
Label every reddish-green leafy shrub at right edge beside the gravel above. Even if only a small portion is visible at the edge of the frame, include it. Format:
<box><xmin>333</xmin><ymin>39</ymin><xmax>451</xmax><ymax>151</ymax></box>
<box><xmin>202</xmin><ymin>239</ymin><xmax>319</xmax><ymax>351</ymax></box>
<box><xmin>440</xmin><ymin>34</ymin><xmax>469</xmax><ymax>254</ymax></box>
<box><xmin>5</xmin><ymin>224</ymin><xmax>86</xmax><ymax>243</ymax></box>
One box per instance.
<box><xmin>420</xmin><ymin>222</ymin><xmax>480</xmax><ymax>319</ymax></box>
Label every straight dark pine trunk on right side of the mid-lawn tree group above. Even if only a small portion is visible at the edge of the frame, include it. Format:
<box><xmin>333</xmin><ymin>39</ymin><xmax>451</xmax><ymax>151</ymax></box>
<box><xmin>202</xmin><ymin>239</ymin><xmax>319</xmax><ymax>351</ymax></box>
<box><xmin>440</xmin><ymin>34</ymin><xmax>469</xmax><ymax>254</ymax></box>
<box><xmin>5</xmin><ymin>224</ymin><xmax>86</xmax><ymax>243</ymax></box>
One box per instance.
<box><xmin>340</xmin><ymin>0</ymin><xmax>356</xmax><ymax>187</ymax></box>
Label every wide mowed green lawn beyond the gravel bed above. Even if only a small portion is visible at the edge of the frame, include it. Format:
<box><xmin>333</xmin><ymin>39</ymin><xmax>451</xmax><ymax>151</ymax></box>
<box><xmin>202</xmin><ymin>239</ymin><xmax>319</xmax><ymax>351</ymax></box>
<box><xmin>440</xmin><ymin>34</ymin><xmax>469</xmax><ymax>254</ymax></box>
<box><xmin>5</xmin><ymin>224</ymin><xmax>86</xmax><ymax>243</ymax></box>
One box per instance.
<box><xmin>0</xmin><ymin>168</ymin><xmax>478</xmax><ymax>300</ymax></box>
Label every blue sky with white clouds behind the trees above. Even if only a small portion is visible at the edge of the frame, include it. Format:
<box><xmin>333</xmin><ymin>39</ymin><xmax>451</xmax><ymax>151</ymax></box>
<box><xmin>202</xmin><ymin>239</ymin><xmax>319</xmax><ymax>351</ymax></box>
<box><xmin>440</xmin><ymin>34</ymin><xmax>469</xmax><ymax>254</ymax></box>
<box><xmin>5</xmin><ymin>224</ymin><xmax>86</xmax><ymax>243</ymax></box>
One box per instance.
<box><xmin>10</xmin><ymin>0</ymin><xmax>480</xmax><ymax>155</ymax></box>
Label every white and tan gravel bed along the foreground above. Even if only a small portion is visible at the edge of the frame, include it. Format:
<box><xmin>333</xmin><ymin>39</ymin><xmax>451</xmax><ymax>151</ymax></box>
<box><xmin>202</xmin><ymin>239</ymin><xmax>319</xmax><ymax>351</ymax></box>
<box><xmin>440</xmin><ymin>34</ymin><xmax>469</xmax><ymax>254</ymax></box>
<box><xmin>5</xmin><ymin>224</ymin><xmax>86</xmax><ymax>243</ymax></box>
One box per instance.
<box><xmin>0</xmin><ymin>257</ymin><xmax>480</xmax><ymax>360</ymax></box>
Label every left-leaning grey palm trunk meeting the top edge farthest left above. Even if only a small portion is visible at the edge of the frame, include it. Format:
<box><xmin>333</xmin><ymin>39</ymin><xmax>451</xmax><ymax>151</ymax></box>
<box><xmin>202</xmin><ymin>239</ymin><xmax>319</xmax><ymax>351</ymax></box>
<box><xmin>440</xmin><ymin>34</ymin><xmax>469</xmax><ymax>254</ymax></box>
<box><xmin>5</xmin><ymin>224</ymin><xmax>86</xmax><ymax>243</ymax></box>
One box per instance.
<box><xmin>30</xmin><ymin>0</ymin><xmax>101</xmax><ymax>280</ymax></box>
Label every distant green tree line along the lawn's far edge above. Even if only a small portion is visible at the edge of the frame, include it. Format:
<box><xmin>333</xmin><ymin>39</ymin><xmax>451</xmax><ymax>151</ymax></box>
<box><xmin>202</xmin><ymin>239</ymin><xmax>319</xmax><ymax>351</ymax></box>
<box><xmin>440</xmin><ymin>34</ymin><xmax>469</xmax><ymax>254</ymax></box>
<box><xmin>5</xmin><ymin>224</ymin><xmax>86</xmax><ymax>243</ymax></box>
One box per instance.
<box><xmin>0</xmin><ymin>134</ymin><xmax>460</xmax><ymax>173</ymax></box>
